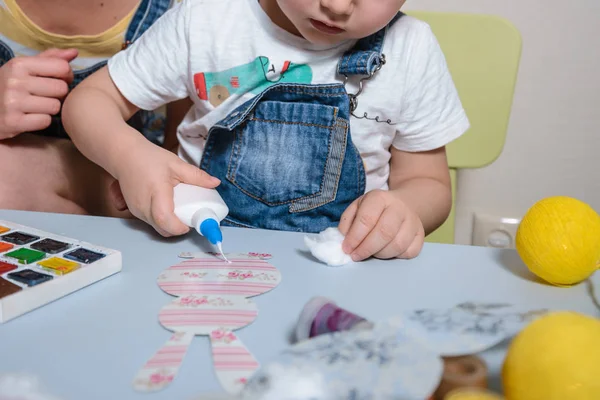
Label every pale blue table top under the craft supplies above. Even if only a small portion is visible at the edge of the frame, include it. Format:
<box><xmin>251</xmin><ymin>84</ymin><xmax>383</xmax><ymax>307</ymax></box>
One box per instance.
<box><xmin>0</xmin><ymin>211</ymin><xmax>600</xmax><ymax>400</ymax></box>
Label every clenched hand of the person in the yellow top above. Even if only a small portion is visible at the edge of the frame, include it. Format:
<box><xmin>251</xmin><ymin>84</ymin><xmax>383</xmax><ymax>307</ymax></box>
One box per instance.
<box><xmin>0</xmin><ymin>49</ymin><xmax>77</xmax><ymax>140</ymax></box>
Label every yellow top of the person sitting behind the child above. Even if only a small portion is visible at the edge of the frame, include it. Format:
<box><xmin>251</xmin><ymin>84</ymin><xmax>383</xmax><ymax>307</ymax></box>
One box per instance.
<box><xmin>0</xmin><ymin>0</ymin><xmax>137</xmax><ymax>70</ymax></box>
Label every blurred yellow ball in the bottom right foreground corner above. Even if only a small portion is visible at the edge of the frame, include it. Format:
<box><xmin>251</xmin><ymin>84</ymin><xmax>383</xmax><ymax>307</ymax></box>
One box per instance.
<box><xmin>502</xmin><ymin>311</ymin><xmax>600</xmax><ymax>400</ymax></box>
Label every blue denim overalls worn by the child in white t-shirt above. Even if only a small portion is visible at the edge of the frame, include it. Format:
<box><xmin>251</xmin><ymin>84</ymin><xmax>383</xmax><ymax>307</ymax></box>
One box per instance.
<box><xmin>200</xmin><ymin>14</ymin><xmax>402</xmax><ymax>232</ymax></box>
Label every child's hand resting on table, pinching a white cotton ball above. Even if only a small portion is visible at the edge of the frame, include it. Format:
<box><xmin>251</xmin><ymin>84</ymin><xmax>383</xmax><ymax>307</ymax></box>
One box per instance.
<box><xmin>339</xmin><ymin>190</ymin><xmax>425</xmax><ymax>261</ymax></box>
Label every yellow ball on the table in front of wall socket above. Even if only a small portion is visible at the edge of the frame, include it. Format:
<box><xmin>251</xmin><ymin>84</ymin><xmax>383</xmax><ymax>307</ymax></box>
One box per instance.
<box><xmin>516</xmin><ymin>196</ymin><xmax>600</xmax><ymax>286</ymax></box>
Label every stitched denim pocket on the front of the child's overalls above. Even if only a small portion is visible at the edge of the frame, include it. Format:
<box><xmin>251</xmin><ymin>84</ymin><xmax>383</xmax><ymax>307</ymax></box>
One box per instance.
<box><xmin>227</xmin><ymin>100</ymin><xmax>346</xmax><ymax>212</ymax></box>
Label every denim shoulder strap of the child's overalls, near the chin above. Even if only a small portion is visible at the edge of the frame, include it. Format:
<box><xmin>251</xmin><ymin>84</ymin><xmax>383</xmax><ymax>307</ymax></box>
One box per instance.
<box><xmin>338</xmin><ymin>12</ymin><xmax>404</xmax><ymax>77</ymax></box>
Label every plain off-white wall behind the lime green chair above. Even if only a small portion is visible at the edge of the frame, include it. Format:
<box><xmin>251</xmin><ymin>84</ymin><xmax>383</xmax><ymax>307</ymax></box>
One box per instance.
<box><xmin>404</xmin><ymin>0</ymin><xmax>600</xmax><ymax>244</ymax></box>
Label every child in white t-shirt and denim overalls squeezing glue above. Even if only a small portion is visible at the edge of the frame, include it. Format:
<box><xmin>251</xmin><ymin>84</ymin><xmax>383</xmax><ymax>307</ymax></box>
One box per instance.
<box><xmin>63</xmin><ymin>0</ymin><xmax>469</xmax><ymax>261</ymax></box>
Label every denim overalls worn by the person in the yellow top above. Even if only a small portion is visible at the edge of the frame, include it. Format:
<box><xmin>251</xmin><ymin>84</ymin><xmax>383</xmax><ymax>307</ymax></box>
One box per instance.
<box><xmin>0</xmin><ymin>0</ymin><xmax>172</xmax><ymax>142</ymax></box>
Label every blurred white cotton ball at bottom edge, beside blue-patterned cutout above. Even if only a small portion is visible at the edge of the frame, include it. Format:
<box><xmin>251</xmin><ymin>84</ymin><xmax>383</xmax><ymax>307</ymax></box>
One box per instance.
<box><xmin>242</xmin><ymin>363</ymin><xmax>336</xmax><ymax>400</ymax></box>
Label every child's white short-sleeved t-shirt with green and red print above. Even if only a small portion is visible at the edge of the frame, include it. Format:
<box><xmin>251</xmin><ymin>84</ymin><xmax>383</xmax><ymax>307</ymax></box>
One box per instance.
<box><xmin>108</xmin><ymin>0</ymin><xmax>469</xmax><ymax>191</ymax></box>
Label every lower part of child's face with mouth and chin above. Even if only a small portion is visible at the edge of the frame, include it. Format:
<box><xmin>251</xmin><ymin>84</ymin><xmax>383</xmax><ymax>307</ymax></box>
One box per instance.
<box><xmin>270</xmin><ymin>0</ymin><xmax>406</xmax><ymax>45</ymax></box>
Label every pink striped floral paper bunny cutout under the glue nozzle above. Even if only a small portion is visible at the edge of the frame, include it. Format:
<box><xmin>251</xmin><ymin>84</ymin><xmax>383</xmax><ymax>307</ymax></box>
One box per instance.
<box><xmin>133</xmin><ymin>253</ymin><xmax>281</xmax><ymax>393</ymax></box>
